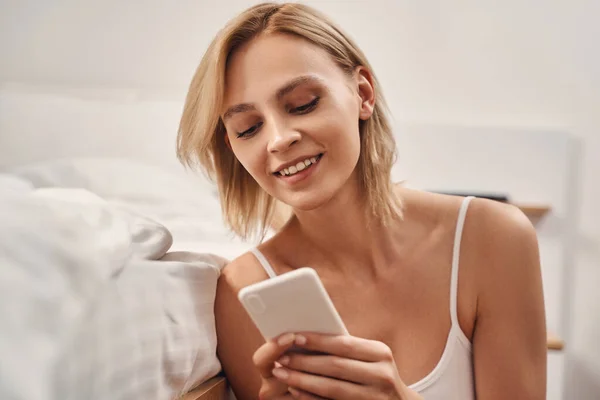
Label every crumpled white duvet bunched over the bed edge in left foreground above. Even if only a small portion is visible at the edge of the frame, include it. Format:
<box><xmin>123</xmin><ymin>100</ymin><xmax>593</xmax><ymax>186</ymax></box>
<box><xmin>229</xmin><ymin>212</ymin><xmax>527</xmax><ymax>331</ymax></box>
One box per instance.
<box><xmin>0</xmin><ymin>187</ymin><xmax>225</xmax><ymax>400</ymax></box>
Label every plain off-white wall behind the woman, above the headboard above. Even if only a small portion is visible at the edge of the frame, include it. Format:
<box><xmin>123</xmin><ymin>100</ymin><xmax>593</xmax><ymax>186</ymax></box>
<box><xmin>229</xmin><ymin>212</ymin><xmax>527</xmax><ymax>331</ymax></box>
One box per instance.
<box><xmin>0</xmin><ymin>0</ymin><xmax>600</xmax><ymax>400</ymax></box>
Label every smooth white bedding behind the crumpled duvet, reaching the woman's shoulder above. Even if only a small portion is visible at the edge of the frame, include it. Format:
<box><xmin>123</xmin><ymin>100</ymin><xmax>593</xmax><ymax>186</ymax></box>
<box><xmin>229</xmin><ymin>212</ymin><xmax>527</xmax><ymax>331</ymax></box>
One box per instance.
<box><xmin>8</xmin><ymin>157</ymin><xmax>253</xmax><ymax>260</ymax></box>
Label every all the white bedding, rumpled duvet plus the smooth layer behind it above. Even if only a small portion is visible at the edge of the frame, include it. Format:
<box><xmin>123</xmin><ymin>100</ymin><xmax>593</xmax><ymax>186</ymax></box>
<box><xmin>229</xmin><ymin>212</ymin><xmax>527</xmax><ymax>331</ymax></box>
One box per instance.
<box><xmin>0</xmin><ymin>159</ymin><xmax>249</xmax><ymax>400</ymax></box>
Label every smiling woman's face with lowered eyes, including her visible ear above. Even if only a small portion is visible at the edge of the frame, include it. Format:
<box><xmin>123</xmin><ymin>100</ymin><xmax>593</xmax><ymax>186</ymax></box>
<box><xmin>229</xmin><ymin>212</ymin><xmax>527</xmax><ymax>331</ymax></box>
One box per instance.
<box><xmin>221</xmin><ymin>34</ymin><xmax>374</xmax><ymax>210</ymax></box>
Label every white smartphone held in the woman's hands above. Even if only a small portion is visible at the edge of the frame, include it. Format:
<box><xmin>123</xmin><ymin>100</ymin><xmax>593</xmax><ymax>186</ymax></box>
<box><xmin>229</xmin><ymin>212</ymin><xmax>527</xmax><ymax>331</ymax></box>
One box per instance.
<box><xmin>238</xmin><ymin>267</ymin><xmax>348</xmax><ymax>340</ymax></box>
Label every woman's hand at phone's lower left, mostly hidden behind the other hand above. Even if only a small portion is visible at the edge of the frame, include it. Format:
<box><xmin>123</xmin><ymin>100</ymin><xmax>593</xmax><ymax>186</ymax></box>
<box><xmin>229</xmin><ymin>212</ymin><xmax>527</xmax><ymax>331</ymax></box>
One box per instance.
<box><xmin>252</xmin><ymin>333</ymin><xmax>296</xmax><ymax>400</ymax></box>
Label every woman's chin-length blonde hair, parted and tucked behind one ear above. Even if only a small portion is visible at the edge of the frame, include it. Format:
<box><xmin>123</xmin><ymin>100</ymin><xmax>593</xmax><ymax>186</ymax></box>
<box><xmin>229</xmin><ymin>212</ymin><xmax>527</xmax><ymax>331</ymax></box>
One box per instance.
<box><xmin>177</xmin><ymin>3</ymin><xmax>402</xmax><ymax>238</ymax></box>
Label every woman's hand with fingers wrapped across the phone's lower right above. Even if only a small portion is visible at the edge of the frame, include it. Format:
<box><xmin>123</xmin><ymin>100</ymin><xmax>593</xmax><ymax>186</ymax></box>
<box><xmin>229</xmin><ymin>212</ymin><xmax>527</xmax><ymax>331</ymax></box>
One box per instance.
<box><xmin>270</xmin><ymin>333</ymin><xmax>421</xmax><ymax>400</ymax></box>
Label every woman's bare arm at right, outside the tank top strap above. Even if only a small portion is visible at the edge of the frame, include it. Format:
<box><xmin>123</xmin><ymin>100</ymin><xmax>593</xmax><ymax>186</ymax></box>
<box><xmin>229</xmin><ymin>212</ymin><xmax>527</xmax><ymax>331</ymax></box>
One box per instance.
<box><xmin>471</xmin><ymin>201</ymin><xmax>547</xmax><ymax>400</ymax></box>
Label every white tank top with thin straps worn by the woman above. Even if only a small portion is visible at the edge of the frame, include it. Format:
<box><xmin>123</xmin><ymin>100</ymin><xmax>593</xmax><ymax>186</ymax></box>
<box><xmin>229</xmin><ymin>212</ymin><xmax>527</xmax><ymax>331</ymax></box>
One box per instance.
<box><xmin>251</xmin><ymin>197</ymin><xmax>475</xmax><ymax>400</ymax></box>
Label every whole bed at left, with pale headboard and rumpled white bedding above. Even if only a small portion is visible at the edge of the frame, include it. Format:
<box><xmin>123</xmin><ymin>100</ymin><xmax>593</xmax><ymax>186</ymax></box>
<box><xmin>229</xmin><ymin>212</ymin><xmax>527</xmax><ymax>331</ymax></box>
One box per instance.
<box><xmin>0</xmin><ymin>86</ymin><xmax>244</xmax><ymax>400</ymax></box>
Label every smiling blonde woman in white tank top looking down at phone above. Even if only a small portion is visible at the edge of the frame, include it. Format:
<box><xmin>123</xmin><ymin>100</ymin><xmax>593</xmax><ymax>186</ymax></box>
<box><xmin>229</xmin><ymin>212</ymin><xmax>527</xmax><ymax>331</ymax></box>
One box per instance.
<box><xmin>178</xmin><ymin>4</ymin><xmax>546</xmax><ymax>400</ymax></box>
